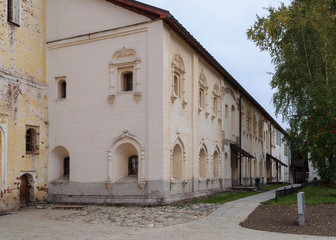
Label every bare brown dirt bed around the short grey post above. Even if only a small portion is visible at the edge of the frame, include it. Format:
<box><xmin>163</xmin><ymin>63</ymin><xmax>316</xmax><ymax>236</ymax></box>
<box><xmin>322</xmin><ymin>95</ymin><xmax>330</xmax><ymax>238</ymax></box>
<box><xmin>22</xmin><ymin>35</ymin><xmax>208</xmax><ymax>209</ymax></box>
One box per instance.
<box><xmin>240</xmin><ymin>204</ymin><xmax>336</xmax><ymax>236</ymax></box>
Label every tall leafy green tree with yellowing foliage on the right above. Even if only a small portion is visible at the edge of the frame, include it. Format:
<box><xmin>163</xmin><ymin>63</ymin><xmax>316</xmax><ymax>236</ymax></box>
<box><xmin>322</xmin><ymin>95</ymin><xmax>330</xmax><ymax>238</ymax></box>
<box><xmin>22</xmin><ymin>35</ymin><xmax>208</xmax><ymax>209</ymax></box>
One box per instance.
<box><xmin>247</xmin><ymin>0</ymin><xmax>336</xmax><ymax>183</ymax></box>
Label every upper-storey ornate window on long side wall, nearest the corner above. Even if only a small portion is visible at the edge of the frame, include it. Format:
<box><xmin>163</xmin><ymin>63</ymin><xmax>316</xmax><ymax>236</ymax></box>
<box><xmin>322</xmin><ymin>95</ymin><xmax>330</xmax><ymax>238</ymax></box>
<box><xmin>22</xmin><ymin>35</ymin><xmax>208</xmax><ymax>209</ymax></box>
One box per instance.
<box><xmin>171</xmin><ymin>53</ymin><xmax>187</xmax><ymax>108</ymax></box>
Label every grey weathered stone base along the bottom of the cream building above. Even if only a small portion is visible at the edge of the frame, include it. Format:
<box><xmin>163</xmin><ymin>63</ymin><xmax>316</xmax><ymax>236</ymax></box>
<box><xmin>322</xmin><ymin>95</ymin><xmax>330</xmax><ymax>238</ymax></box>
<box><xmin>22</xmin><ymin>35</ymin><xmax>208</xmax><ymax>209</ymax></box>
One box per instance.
<box><xmin>47</xmin><ymin>179</ymin><xmax>230</xmax><ymax>205</ymax></box>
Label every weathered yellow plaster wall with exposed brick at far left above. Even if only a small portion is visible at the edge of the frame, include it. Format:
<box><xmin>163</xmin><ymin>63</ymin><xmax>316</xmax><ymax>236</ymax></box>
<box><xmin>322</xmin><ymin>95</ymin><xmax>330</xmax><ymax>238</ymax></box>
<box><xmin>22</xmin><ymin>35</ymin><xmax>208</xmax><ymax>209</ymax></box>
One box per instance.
<box><xmin>0</xmin><ymin>0</ymin><xmax>48</xmax><ymax>211</ymax></box>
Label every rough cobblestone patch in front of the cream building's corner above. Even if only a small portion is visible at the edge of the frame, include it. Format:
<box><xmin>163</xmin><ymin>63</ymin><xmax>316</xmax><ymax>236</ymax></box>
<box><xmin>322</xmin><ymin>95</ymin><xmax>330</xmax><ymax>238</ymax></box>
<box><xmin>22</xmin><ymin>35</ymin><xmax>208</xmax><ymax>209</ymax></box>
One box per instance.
<box><xmin>56</xmin><ymin>203</ymin><xmax>221</xmax><ymax>228</ymax></box>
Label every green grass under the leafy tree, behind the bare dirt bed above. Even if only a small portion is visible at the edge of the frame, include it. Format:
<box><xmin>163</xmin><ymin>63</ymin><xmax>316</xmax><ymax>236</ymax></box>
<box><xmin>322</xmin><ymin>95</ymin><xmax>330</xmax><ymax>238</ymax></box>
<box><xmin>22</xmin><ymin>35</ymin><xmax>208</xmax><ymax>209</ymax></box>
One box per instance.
<box><xmin>263</xmin><ymin>184</ymin><xmax>336</xmax><ymax>205</ymax></box>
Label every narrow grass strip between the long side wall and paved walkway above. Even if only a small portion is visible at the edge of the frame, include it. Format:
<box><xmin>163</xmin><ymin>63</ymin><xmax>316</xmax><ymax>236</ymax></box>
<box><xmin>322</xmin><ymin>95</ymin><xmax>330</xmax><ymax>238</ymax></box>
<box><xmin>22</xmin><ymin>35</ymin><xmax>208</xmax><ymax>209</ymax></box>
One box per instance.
<box><xmin>181</xmin><ymin>191</ymin><xmax>258</xmax><ymax>204</ymax></box>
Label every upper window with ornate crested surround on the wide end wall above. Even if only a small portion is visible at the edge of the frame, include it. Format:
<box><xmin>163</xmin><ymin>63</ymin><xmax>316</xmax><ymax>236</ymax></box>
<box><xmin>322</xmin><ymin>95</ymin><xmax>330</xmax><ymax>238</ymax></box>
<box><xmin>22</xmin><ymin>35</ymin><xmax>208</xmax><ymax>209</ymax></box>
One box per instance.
<box><xmin>108</xmin><ymin>47</ymin><xmax>142</xmax><ymax>104</ymax></box>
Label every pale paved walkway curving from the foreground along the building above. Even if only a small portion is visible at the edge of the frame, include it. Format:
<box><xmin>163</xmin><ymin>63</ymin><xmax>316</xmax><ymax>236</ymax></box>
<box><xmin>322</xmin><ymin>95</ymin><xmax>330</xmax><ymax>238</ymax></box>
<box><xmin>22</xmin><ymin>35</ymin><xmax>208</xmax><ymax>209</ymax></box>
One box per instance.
<box><xmin>0</xmin><ymin>188</ymin><xmax>336</xmax><ymax>240</ymax></box>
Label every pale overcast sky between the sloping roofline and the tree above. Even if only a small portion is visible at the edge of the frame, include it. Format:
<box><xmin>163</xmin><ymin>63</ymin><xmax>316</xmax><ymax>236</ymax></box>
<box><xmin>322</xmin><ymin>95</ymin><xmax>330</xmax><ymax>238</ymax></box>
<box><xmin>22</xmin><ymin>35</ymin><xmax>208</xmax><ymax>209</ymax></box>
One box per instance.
<box><xmin>139</xmin><ymin>0</ymin><xmax>290</xmax><ymax>128</ymax></box>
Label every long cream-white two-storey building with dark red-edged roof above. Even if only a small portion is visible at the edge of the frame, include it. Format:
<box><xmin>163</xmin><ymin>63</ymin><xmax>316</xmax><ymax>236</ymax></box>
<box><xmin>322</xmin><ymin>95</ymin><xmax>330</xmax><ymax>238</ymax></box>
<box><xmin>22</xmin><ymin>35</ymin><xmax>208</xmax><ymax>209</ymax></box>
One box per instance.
<box><xmin>47</xmin><ymin>0</ymin><xmax>290</xmax><ymax>204</ymax></box>
